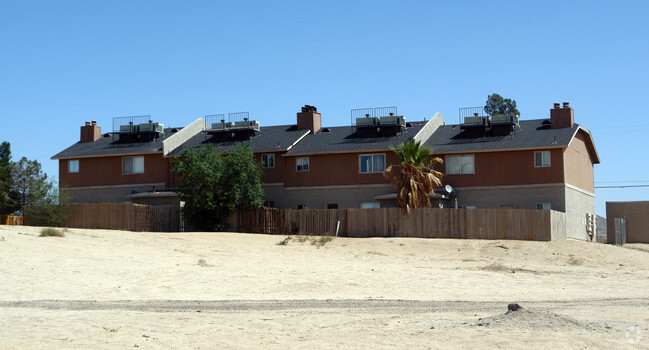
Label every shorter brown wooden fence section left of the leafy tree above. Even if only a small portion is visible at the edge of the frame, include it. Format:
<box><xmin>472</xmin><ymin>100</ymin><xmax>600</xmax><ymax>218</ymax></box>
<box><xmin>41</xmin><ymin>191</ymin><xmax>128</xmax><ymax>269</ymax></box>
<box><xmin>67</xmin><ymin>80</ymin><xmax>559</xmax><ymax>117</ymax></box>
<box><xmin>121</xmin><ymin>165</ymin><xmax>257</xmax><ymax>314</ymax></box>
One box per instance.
<box><xmin>65</xmin><ymin>203</ymin><xmax>180</xmax><ymax>232</ymax></box>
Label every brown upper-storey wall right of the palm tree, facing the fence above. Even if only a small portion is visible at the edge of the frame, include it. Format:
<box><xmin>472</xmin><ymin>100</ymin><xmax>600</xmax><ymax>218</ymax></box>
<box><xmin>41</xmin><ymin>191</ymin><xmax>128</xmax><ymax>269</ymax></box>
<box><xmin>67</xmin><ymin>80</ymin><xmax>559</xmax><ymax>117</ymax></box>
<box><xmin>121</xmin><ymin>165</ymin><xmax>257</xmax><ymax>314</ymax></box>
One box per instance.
<box><xmin>437</xmin><ymin>149</ymin><xmax>563</xmax><ymax>187</ymax></box>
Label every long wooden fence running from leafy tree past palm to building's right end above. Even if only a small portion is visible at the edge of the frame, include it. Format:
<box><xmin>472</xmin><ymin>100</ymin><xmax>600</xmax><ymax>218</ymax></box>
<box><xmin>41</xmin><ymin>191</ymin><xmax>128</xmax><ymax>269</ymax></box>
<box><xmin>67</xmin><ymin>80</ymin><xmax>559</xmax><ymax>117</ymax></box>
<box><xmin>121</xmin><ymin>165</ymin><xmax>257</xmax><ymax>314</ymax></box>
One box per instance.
<box><xmin>238</xmin><ymin>208</ymin><xmax>566</xmax><ymax>241</ymax></box>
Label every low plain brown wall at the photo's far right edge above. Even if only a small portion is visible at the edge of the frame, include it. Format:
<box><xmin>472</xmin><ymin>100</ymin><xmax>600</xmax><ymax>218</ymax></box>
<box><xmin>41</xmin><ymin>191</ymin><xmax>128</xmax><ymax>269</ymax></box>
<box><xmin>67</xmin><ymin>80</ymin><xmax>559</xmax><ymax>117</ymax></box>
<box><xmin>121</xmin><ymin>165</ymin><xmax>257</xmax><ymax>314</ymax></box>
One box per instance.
<box><xmin>606</xmin><ymin>201</ymin><xmax>649</xmax><ymax>244</ymax></box>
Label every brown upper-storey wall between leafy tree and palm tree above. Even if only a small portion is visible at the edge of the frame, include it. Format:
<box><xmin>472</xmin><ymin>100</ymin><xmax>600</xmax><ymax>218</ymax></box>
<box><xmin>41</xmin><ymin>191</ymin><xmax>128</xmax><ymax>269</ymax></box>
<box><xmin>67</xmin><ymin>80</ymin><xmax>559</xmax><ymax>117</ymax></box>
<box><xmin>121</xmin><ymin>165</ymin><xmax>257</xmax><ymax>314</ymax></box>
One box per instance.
<box><xmin>284</xmin><ymin>151</ymin><xmax>399</xmax><ymax>187</ymax></box>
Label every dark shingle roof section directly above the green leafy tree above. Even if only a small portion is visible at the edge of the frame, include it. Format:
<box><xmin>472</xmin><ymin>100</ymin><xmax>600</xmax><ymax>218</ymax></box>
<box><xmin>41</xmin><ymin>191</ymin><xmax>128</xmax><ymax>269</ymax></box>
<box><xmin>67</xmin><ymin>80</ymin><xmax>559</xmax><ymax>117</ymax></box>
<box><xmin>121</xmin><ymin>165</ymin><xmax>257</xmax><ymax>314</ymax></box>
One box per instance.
<box><xmin>169</xmin><ymin>125</ymin><xmax>309</xmax><ymax>156</ymax></box>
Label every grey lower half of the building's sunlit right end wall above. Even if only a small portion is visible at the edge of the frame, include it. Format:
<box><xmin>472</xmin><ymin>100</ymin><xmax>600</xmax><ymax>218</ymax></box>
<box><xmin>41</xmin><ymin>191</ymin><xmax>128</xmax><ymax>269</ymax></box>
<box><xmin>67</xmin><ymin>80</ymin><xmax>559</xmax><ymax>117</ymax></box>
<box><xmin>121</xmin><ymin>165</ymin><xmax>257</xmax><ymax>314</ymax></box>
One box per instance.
<box><xmin>565</xmin><ymin>186</ymin><xmax>595</xmax><ymax>241</ymax></box>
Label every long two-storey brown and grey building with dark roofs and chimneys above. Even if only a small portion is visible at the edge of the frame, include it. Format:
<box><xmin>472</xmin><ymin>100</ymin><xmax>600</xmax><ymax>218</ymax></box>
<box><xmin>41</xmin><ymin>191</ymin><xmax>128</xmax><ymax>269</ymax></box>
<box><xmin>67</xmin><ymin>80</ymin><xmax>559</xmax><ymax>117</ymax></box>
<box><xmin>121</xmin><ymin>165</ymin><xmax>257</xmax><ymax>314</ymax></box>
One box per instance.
<box><xmin>53</xmin><ymin>103</ymin><xmax>599</xmax><ymax>239</ymax></box>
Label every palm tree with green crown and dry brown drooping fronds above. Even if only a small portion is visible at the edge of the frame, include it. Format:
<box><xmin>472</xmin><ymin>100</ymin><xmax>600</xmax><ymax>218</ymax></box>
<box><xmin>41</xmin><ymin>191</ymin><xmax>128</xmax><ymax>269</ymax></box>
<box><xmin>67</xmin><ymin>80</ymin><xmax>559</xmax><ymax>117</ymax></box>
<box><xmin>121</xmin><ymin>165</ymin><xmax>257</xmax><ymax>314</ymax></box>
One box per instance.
<box><xmin>383</xmin><ymin>141</ymin><xmax>443</xmax><ymax>213</ymax></box>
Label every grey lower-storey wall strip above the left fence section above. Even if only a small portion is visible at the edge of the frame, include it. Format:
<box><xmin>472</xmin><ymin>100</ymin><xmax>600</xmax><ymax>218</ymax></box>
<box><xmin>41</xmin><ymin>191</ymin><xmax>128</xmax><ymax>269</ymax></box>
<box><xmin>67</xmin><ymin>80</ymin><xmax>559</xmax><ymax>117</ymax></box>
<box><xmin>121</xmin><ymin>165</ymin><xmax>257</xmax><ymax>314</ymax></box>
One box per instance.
<box><xmin>61</xmin><ymin>182</ymin><xmax>165</xmax><ymax>203</ymax></box>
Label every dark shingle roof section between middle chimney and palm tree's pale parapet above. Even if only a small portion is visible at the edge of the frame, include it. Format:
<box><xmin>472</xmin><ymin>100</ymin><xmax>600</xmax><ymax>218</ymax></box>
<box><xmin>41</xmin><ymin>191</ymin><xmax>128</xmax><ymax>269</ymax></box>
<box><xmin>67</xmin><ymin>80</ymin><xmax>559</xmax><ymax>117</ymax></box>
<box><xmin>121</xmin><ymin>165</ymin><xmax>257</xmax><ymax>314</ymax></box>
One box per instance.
<box><xmin>287</xmin><ymin>122</ymin><xmax>426</xmax><ymax>155</ymax></box>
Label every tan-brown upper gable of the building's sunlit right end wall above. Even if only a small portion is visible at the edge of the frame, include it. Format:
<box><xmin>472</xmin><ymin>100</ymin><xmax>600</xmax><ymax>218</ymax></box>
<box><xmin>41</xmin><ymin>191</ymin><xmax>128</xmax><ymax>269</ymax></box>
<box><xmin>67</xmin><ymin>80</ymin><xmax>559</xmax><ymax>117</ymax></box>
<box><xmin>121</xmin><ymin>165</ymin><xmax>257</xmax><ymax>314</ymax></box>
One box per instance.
<box><xmin>564</xmin><ymin>131</ymin><xmax>595</xmax><ymax>192</ymax></box>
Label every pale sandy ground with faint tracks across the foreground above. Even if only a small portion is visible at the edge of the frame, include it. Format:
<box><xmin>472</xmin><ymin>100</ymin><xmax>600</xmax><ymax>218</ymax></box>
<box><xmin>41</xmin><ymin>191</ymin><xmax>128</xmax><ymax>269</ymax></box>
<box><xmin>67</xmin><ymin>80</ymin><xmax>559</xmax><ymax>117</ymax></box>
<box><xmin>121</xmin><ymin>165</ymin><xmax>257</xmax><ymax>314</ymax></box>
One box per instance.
<box><xmin>0</xmin><ymin>226</ymin><xmax>649</xmax><ymax>349</ymax></box>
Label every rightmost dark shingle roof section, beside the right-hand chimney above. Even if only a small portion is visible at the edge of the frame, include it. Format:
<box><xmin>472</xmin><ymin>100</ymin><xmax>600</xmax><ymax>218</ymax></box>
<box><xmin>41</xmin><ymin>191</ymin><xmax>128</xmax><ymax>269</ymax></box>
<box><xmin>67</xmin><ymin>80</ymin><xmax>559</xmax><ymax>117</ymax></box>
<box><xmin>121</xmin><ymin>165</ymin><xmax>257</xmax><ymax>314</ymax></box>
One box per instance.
<box><xmin>424</xmin><ymin>119</ymin><xmax>579</xmax><ymax>153</ymax></box>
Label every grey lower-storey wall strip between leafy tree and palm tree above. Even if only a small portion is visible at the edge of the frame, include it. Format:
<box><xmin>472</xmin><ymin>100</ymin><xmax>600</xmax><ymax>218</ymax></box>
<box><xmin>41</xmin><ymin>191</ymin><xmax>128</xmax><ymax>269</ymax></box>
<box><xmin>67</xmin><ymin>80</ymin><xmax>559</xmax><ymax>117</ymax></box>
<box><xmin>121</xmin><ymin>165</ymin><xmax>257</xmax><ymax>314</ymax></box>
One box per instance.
<box><xmin>264</xmin><ymin>183</ymin><xmax>394</xmax><ymax>209</ymax></box>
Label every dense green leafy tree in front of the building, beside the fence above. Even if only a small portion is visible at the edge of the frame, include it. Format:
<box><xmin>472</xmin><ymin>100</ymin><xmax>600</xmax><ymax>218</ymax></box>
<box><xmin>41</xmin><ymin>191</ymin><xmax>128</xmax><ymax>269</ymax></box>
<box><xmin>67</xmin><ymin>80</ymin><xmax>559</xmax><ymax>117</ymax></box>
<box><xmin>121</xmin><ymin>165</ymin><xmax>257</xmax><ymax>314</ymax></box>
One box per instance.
<box><xmin>171</xmin><ymin>144</ymin><xmax>263</xmax><ymax>231</ymax></box>
